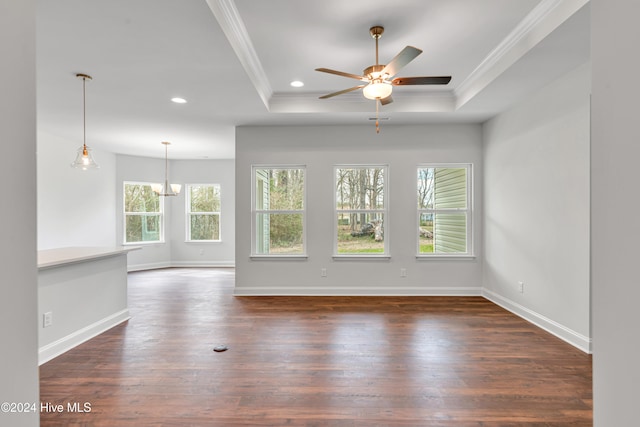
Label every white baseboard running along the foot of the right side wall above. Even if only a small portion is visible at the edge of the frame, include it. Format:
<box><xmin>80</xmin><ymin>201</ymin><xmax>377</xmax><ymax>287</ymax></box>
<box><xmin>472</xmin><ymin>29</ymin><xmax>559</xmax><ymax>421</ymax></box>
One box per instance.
<box><xmin>482</xmin><ymin>288</ymin><xmax>592</xmax><ymax>354</ymax></box>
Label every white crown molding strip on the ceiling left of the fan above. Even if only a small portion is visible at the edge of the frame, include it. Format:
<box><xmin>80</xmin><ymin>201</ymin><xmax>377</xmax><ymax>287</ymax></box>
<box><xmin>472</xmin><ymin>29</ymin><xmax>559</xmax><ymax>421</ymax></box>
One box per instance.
<box><xmin>207</xmin><ymin>0</ymin><xmax>273</xmax><ymax>109</ymax></box>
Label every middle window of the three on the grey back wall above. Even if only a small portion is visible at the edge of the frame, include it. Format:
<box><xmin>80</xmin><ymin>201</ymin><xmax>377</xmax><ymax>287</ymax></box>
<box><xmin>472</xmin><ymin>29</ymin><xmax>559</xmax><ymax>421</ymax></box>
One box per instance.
<box><xmin>334</xmin><ymin>166</ymin><xmax>389</xmax><ymax>256</ymax></box>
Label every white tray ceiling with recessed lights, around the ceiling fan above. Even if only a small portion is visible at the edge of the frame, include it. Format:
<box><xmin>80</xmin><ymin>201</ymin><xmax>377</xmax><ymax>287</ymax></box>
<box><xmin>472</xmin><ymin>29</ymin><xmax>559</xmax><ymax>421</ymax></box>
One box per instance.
<box><xmin>37</xmin><ymin>0</ymin><xmax>589</xmax><ymax>159</ymax></box>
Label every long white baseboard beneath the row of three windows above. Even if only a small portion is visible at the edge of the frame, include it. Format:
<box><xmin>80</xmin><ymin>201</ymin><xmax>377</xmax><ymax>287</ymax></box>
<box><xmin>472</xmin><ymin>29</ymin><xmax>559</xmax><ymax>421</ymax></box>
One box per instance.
<box><xmin>233</xmin><ymin>286</ymin><xmax>482</xmax><ymax>296</ymax></box>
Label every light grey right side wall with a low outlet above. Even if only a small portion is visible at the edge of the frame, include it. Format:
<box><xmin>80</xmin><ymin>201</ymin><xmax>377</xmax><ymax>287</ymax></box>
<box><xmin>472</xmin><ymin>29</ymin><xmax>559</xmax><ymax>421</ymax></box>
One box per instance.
<box><xmin>483</xmin><ymin>64</ymin><xmax>591</xmax><ymax>350</ymax></box>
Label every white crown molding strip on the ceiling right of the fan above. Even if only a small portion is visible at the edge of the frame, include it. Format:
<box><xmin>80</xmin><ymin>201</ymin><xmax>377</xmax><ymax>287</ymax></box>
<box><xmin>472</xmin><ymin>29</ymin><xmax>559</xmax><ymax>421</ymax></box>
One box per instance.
<box><xmin>455</xmin><ymin>0</ymin><xmax>589</xmax><ymax>109</ymax></box>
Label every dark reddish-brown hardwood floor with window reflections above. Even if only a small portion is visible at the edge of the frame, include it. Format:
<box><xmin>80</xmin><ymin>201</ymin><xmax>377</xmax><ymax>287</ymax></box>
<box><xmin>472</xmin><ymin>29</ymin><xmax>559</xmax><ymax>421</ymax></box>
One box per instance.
<box><xmin>40</xmin><ymin>269</ymin><xmax>592</xmax><ymax>427</ymax></box>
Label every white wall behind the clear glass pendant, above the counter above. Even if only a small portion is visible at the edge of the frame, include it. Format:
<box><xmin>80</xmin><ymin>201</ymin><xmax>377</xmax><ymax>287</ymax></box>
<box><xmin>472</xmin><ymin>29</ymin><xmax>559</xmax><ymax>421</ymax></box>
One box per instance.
<box><xmin>38</xmin><ymin>132</ymin><xmax>118</xmax><ymax>250</ymax></box>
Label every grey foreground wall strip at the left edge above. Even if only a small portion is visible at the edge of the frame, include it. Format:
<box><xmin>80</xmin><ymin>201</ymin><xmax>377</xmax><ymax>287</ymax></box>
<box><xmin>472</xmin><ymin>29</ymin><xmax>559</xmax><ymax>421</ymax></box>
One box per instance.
<box><xmin>0</xmin><ymin>0</ymin><xmax>40</xmax><ymax>427</ymax></box>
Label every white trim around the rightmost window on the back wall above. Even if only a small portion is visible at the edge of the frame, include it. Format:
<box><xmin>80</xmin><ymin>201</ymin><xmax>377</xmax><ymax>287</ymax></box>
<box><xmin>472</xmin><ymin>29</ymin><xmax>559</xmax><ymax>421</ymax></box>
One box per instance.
<box><xmin>413</xmin><ymin>163</ymin><xmax>476</xmax><ymax>260</ymax></box>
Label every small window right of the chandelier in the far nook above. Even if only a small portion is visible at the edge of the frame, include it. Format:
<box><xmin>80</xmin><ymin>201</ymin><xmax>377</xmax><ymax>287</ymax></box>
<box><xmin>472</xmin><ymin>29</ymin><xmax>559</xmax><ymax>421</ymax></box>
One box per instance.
<box><xmin>185</xmin><ymin>184</ymin><xmax>220</xmax><ymax>242</ymax></box>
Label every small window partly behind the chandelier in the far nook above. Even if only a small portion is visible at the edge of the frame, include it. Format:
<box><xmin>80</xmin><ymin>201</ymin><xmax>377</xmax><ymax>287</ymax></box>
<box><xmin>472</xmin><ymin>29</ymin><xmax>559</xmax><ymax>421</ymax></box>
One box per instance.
<box><xmin>124</xmin><ymin>182</ymin><xmax>164</xmax><ymax>243</ymax></box>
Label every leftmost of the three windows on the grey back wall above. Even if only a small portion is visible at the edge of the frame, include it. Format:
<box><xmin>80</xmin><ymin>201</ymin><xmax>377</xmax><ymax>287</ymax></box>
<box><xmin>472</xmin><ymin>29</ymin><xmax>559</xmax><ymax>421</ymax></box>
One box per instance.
<box><xmin>251</xmin><ymin>166</ymin><xmax>306</xmax><ymax>256</ymax></box>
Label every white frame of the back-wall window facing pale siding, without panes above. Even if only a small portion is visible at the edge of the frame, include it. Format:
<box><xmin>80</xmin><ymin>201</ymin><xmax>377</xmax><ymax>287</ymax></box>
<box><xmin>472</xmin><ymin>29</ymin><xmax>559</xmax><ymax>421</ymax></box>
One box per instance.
<box><xmin>414</xmin><ymin>163</ymin><xmax>475</xmax><ymax>260</ymax></box>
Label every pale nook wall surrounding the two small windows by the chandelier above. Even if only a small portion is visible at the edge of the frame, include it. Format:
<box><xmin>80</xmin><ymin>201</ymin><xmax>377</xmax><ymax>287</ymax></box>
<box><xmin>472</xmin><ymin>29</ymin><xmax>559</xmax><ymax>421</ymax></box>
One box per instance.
<box><xmin>115</xmin><ymin>155</ymin><xmax>235</xmax><ymax>270</ymax></box>
